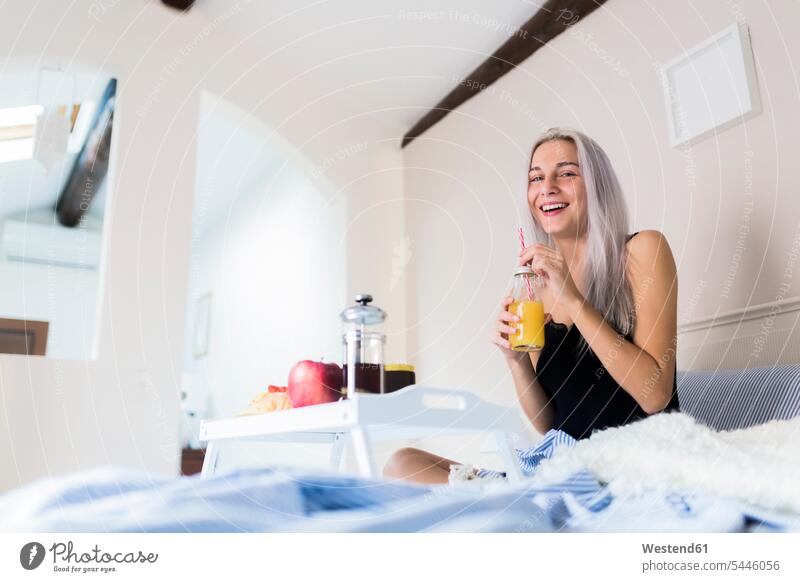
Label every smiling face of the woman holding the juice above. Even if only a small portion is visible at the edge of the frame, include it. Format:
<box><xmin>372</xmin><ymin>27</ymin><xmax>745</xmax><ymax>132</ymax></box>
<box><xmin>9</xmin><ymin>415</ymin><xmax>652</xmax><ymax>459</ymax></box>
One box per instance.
<box><xmin>528</xmin><ymin>140</ymin><xmax>586</xmax><ymax>238</ymax></box>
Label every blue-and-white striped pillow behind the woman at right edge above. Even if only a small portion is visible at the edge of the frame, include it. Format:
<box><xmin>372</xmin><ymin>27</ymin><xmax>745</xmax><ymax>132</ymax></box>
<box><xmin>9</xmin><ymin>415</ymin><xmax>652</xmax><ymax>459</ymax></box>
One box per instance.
<box><xmin>677</xmin><ymin>364</ymin><xmax>800</xmax><ymax>430</ymax></box>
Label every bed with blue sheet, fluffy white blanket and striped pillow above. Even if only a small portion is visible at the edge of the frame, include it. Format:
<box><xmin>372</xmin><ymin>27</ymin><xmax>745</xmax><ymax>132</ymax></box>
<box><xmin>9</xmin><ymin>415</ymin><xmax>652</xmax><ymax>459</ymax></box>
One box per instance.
<box><xmin>0</xmin><ymin>365</ymin><xmax>800</xmax><ymax>532</ymax></box>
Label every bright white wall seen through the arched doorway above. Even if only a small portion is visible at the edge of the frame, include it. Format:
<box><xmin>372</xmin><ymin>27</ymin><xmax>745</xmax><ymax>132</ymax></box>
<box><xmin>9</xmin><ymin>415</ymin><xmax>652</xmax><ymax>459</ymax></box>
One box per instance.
<box><xmin>185</xmin><ymin>92</ymin><xmax>346</xmax><ymax>418</ymax></box>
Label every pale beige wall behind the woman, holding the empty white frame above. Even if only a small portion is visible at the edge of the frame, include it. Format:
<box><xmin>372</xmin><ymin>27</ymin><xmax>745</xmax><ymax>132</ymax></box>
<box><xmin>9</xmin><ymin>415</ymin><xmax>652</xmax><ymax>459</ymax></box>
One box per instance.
<box><xmin>404</xmin><ymin>0</ymin><xmax>800</xmax><ymax>466</ymax></box>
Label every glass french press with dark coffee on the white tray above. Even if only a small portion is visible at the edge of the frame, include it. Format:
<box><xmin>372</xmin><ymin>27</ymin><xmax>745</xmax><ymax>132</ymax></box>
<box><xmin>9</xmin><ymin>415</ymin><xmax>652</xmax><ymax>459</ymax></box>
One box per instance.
<box><xmin>341</xmin><ymin>293</ymin><xmax>386</xmax><ymax>398</ymax></box>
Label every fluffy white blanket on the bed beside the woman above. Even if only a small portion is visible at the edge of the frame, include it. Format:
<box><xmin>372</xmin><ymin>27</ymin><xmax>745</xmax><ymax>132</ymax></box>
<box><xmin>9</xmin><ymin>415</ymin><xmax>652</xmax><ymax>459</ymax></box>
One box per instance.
<box><xmin>533</xmin><ymin>413</ymin><xmax>800</xmax><ymax>514</ymax></box>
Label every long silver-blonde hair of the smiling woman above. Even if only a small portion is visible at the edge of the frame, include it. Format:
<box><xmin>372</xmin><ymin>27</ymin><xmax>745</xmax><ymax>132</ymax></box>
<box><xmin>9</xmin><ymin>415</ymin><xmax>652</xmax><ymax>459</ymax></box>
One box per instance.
<box><xmin>530</xmin><ymin>127</ymin><xmax>634</xmax><ymax>347</ymax></box>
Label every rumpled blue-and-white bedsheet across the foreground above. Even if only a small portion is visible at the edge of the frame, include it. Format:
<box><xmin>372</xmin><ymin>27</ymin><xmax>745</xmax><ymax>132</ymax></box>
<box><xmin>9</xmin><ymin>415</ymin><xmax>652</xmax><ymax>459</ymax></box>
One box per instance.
<box><xmin>0</xmin><ymin>431</ymin><xmax>793</xmax><ymax>532</ymax></box>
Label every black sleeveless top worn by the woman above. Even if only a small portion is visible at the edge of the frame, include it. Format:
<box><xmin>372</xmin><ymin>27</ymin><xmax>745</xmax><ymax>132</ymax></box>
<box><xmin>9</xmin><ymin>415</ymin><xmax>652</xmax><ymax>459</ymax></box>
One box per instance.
<box><xmin>536</xmin><ymin>232</ymin><xmax>678</xmax><ymax>439</ymax></box>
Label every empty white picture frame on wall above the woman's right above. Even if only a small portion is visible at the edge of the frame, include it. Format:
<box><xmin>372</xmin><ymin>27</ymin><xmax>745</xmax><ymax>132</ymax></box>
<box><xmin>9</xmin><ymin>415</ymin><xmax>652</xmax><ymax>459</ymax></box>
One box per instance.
<box><xmin>661</xmin><ymin>23</ymin><xmax>761</xmax><ymax>147</ymax></box>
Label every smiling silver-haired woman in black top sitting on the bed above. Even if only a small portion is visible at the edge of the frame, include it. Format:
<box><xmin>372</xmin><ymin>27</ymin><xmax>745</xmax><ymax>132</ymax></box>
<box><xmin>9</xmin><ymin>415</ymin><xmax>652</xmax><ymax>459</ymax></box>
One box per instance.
<box><xmin>384</xmin><ymin>128</ymin><xmax>678</xmax><ymax>483</ymax></box>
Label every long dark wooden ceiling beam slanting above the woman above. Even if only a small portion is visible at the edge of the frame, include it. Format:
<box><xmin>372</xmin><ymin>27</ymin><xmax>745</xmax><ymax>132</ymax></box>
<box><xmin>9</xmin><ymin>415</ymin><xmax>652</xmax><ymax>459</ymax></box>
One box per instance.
<box><xmin>402</xmin><ymin>0</ymin><xmax>606</xmax><ymax>147</ymax></box>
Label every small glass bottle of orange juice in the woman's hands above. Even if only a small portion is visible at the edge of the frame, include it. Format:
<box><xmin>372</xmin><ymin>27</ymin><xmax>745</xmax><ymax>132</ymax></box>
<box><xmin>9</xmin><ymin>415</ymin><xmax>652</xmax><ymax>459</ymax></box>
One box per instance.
<box><xmin>508</xmin><ymin>267</ymin><xmax>544</xmax><ymax>352</ymax></box>
